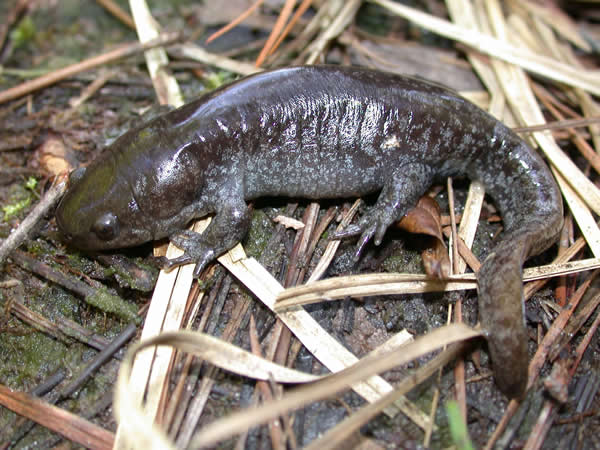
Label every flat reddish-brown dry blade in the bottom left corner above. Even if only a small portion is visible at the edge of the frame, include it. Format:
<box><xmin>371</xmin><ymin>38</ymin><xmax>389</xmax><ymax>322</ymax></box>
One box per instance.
<box><xmin>0</xmin><ymin>385</ymin><xmax>114</xmax><ymax>449</ymax></box>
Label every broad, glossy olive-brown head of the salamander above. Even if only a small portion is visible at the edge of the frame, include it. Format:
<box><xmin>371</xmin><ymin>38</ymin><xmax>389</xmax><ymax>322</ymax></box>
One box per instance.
<box><xmin>56</xmin><ymin>115</ymin><xmax>206</xmax><ymax>250</ymax></box>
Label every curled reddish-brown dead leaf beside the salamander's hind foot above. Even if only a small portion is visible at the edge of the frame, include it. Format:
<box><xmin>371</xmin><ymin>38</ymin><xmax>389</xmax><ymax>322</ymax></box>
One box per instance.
<box><xmin>397</xmin><ymin>196</ymin><xmax>450</xmax><ymax>279</ymax></box>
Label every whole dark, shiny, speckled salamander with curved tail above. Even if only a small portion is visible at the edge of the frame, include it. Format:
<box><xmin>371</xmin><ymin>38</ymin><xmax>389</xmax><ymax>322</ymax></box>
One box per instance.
<box><xmin>56</xmin><ymin>66</ymin><xmax>563</xmax><ymax>397</ymax></box>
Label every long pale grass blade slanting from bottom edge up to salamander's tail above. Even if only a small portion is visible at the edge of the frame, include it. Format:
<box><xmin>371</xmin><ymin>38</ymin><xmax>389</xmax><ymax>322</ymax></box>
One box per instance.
<box><xmin>192</xmin><ymin>324</ymin><xmax>481</xmax><ymax>448</ymax></box>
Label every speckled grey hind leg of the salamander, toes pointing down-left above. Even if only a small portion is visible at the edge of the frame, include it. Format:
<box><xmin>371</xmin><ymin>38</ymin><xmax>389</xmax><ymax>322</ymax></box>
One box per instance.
<box><xmin>333</xmin><ymin>163</ymin><xmax>433</xmax><ymax>260</ymax></box>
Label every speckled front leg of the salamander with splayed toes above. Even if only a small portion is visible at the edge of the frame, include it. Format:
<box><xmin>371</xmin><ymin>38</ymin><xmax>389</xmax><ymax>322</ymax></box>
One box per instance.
<box><xmin>165</xmin><ymin>199</ymin><xmax>250</xmax><ymax>277</ymax></box>
